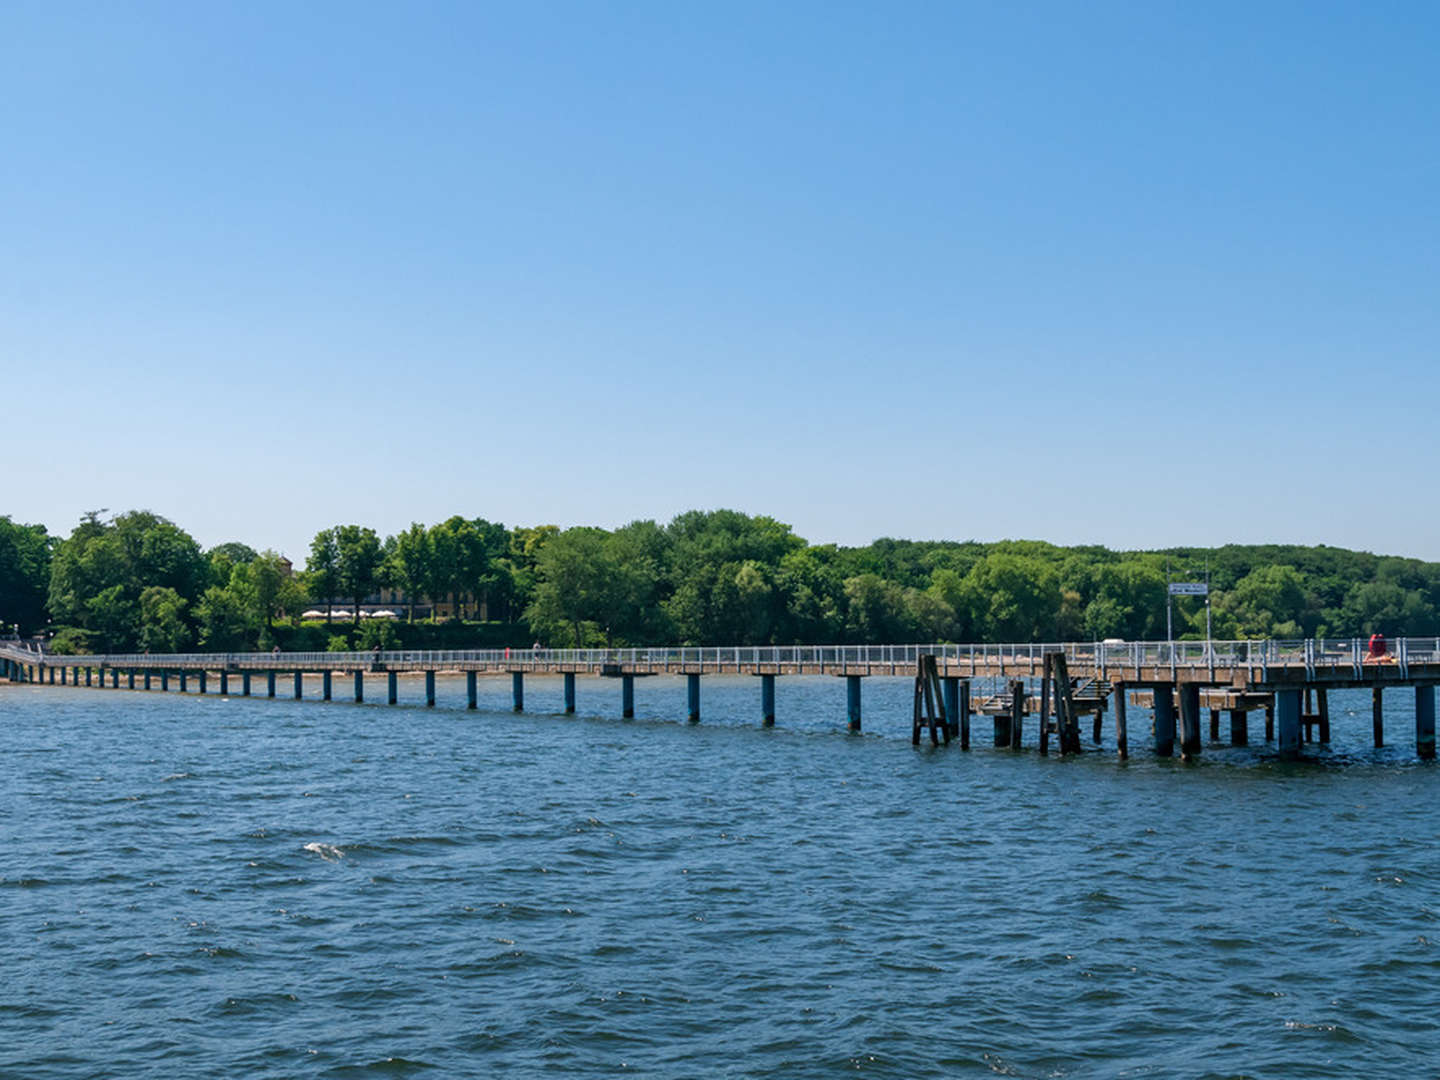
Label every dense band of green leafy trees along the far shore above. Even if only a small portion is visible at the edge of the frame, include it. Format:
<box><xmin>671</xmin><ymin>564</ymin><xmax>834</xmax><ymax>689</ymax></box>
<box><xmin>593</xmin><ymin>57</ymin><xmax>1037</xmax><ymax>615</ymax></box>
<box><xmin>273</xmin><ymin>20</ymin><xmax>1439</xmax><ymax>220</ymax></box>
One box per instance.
<box><xmin>0</xmin><ymin>510</ymin><xmax>1440</xmax><ymax>652</ymax></box>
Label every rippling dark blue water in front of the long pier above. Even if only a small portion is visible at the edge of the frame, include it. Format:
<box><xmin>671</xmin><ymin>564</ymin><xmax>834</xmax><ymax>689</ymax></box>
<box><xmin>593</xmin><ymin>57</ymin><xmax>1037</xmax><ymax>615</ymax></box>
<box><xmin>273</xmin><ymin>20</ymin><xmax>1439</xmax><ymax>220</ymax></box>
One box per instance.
<box><xmin>0</xmin><ymin>678</ymin><xmax>1440</xmax><ymax>1080</ymax></box>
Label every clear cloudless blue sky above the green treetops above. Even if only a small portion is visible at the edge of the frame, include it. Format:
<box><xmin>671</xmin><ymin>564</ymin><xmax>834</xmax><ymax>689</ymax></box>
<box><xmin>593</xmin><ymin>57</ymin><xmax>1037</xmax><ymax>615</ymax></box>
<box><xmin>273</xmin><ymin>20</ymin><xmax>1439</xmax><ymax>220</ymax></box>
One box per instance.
<box><xmin>0</xmin><ymin>0</ymin><xmax>1440</xmax><ymax>562</ymax></box>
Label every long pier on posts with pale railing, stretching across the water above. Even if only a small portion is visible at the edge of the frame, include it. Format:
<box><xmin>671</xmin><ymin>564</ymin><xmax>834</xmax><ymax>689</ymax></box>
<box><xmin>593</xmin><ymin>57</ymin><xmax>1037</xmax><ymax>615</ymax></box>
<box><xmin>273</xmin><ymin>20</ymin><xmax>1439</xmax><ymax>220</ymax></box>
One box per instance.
<box><xmin>0</xmin><ymin>638</ymin><xmax>1440</xmax><ymax>757</ymax></box>
